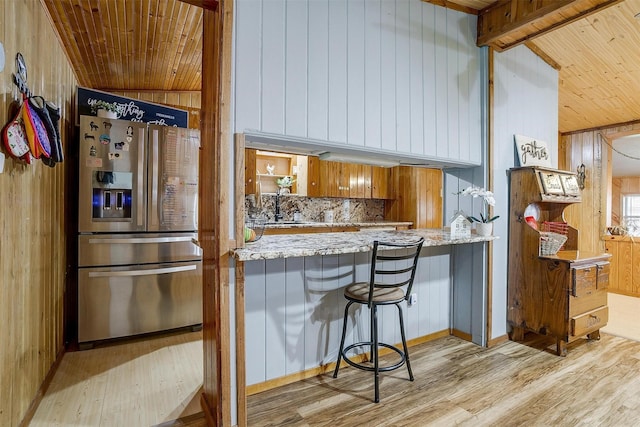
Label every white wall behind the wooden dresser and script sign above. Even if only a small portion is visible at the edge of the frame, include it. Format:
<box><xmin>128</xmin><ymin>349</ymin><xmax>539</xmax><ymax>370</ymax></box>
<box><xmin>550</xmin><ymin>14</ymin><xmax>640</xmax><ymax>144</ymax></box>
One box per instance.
<box><xmin>490</xmin><ymin>46</ymin><xmax>558</xmax><ymax>338</ymax></box>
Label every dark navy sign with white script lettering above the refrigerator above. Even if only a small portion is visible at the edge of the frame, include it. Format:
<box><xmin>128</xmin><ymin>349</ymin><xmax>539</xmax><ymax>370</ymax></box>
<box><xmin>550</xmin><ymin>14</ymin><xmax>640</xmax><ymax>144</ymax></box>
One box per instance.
<box><xmin>77</xmin><ymin>87</ymin><xmax>189</xmax><ymax>128</ymax></box>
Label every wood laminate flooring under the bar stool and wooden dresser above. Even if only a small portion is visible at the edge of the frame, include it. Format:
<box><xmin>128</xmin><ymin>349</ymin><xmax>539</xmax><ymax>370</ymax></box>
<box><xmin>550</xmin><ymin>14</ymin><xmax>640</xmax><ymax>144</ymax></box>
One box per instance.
<box><xmin>248</xmin><ymin>334</ymin><xmax>640</xmax><ymax>427</ymax></box>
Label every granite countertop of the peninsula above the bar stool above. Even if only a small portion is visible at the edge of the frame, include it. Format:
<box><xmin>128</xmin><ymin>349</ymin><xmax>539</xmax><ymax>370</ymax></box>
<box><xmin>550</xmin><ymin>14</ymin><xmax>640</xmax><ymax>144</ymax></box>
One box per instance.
<box><xmin>231</xmin><ymin>231</ymin><xmax>497</xmax><ymax>261</ymax></box>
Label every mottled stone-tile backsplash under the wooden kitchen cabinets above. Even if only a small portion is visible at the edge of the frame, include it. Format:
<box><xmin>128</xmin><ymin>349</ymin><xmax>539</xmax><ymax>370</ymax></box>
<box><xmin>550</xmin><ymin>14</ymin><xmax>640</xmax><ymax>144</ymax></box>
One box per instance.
<box><xmin>245</xmin><ymin>194</ymin><xmax>385</xmax><ymax>222</ymax></box>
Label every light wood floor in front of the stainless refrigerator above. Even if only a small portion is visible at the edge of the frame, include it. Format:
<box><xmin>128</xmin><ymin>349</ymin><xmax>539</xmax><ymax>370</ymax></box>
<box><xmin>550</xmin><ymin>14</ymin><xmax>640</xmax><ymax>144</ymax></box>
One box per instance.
<box><xmin>29</xmin><ymin>332</ymin><xmax>203</xmax><ymax>427</ymax></box>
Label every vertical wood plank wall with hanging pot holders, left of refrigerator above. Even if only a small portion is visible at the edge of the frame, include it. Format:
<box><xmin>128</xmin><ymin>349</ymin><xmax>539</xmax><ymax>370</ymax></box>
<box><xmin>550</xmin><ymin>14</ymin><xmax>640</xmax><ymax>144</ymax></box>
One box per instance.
<box><xmin>0</xmin><ymin>0</ymin><xmax>77</xmax><ymax>426</ymax></box>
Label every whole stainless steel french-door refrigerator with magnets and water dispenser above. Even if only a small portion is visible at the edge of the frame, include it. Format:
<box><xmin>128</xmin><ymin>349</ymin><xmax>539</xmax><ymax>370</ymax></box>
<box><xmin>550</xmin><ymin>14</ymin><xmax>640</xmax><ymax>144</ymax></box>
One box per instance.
<box><xmin>78</xmin><ymin>116</ymin><xmax>202</xmax><ymax>345</ymax></box>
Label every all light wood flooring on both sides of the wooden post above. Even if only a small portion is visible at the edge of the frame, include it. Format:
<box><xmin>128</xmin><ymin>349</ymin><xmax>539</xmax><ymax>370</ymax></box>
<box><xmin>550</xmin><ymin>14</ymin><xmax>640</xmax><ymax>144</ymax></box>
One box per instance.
<box><xmin>30</xmin><ymin>294</ymin><xmax>640</xmax><ymax>427</ymax></box>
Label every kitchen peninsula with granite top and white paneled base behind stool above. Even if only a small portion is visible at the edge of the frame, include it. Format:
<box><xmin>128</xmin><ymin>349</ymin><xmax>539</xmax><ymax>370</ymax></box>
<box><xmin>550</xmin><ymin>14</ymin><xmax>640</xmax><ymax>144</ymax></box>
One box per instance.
<box><xmin>231</xmin><ymin>229</ymin><xmax>497</xmax><ymax>401</ymax></box>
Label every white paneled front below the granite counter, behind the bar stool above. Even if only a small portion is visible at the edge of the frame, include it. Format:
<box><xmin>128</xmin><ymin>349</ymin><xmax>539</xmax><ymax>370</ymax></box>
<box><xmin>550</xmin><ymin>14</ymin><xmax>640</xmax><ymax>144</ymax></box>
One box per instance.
<box><xmin>245</xmin><ymin>247</ymin><xmax>450</xmax><ymax>385</ymax></box>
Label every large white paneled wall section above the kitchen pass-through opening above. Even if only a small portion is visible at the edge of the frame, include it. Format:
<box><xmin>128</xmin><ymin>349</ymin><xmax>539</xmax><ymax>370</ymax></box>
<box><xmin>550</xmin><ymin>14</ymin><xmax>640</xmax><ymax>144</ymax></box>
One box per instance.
<box><xmin>233</xmin><ymin>0</ymin><xmax>481</xmax><ymax>164</ymax></box>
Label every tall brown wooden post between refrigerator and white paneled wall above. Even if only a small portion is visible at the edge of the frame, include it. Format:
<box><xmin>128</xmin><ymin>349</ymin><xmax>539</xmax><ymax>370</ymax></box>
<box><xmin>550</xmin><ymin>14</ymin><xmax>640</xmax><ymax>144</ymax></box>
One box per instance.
<box><xmin>198</xmin><ymin>0</ymin><xmax>233</xmax><ymax>426</ymax></box>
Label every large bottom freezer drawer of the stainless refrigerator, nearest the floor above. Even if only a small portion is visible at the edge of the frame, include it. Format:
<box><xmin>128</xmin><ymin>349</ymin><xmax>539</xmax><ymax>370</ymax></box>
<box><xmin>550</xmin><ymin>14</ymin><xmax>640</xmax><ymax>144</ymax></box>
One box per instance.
<box><xmin>78</xmin><ymin>261</ymin><xmax>202</xmax><ymax>342</ymax></box>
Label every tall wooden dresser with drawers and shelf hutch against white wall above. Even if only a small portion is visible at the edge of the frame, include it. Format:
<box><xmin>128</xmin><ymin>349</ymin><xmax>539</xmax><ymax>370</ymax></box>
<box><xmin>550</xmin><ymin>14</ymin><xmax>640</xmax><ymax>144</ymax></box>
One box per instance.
<box><xmin>507</xmin><ymin>167</ymin><xmax>610</xmax><ymax>356</ymax></box>
